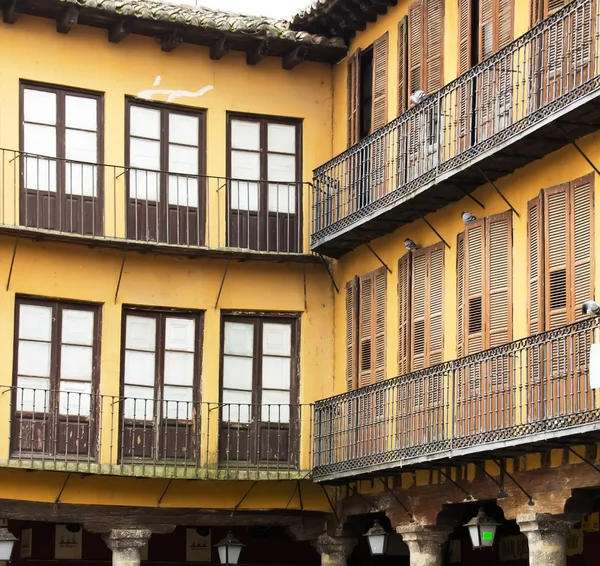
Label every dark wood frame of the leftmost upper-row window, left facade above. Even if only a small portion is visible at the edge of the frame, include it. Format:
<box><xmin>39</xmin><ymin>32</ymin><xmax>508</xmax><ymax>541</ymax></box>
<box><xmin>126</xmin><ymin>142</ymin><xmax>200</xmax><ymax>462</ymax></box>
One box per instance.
<box><xmin>19</xmin><ymin>80</ymin><xmax>105</xmax><ymax>236</ymax></box>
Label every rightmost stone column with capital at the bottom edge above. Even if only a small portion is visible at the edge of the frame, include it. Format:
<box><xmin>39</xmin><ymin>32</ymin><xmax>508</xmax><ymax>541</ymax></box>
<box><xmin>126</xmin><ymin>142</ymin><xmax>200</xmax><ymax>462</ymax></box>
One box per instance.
<box><xmin>517</xmin><ymin>513</ymin><xmax>571</xmax><ymax>566</ymax></box>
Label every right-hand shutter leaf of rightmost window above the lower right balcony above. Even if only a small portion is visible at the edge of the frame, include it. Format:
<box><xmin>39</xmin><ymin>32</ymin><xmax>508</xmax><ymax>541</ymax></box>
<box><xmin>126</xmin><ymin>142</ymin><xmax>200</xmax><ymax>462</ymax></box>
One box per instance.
<box><xmin>569</xmin><ymin>174</ymin><xmax>595</xmax><ymax>322</ymax></box>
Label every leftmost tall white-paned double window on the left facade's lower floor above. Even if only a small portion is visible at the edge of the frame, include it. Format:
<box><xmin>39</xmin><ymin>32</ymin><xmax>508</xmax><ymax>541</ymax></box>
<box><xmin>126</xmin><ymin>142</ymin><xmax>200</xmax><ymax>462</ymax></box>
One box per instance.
<box><xmin>12</xmin><ymin>298</ymin><xmax>100</xmax><ymax>456</ymax></box>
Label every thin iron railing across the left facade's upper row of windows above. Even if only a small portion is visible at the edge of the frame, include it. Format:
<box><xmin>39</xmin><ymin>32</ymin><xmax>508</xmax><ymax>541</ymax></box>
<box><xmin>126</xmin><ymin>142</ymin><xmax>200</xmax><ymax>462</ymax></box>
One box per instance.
<box><xmin>0</xmin><ymin>149</ymin><xmax>311</xmax><ymax>254</ymax></box>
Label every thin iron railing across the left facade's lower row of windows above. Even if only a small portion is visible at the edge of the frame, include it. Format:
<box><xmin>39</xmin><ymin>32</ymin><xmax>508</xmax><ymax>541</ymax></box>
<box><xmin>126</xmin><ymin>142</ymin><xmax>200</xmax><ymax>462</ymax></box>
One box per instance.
<box><xmin>0</xmin><ymin>392</ymin><xmax>313</xmax><ymax>480</ymax></box>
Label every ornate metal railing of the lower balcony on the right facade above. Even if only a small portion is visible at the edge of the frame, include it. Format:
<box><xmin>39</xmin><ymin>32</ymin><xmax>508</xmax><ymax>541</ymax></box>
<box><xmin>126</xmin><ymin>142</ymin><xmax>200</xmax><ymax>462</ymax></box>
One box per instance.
<box><xmin>313</xmin><ymin>319</ymin><xmax>600</xmax><ymax>478</ymax></box>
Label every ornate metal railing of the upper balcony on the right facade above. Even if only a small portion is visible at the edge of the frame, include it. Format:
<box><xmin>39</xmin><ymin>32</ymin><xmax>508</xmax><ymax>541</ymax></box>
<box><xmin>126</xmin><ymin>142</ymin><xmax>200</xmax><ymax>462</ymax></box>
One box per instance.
<box><xmin>311</xmin><ymin>0</ymin><xmax>600</xmax><ymax>242</ymax></box>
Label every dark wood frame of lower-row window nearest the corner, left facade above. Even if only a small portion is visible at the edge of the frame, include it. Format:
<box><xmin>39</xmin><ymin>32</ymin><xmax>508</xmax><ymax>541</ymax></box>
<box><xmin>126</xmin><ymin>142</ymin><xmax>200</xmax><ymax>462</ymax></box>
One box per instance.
<box><xmin>219</xmin><ymin>311</ymin><xmax>302</xmax><ymax>467</ymax></box>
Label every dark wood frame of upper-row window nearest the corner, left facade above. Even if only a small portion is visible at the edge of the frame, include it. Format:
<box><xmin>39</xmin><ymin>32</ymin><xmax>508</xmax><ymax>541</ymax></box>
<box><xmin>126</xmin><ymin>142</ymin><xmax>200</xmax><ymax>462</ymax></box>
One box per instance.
<box><xmin>226</xmin><ymin>112</ymin><xmax>304</xmax><ymax>252</ymax></box>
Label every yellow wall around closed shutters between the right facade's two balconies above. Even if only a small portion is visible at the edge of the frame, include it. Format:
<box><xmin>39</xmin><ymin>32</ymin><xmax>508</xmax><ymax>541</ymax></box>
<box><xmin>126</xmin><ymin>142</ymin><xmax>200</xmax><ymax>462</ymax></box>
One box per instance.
<box><xmin>334</xmin><ymin>129</ymin><xmax>600</xmax><ymax>393</ymax></box>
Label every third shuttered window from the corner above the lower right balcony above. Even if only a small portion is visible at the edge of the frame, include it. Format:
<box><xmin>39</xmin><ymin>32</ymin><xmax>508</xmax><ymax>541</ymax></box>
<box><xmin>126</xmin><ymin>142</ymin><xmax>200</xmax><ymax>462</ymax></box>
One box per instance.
<box><xmin>457</xmin><ymin>212</ymin><xmax>512</xmax><ymax>357</ymax></box>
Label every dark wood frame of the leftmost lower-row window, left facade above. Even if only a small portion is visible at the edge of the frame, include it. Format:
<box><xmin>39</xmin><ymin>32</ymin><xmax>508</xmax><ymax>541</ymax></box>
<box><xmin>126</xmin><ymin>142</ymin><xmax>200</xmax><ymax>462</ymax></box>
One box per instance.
<box><xmin>11</xmin><ymin>295</ymin><xmax>102</xmax><ymax>459</ymax></box>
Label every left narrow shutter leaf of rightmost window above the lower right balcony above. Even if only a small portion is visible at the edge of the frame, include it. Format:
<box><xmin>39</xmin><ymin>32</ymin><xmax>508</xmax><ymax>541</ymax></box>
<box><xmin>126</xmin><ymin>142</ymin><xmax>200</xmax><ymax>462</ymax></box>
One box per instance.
<box><xmin>527</xmin><ymin>196</ymin><xmax>545</xmax><ymax>335</ymax></box>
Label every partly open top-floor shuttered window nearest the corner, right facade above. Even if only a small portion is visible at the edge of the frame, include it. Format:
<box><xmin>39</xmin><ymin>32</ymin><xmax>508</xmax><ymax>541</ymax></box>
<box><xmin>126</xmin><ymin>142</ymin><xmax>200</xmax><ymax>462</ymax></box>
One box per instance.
<box><xmin>348</xmin><ymin>33</ymin><xmax>388</xmax><ymax>147</ymax></box>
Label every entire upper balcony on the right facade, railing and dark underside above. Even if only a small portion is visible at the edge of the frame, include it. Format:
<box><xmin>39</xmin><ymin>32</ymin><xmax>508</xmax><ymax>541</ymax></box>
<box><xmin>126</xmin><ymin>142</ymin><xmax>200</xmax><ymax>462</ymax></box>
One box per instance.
<box><xmin>311</xmin><ymin>0</ymin><xmax>600</xmax><ymax>258</ymax></box>
